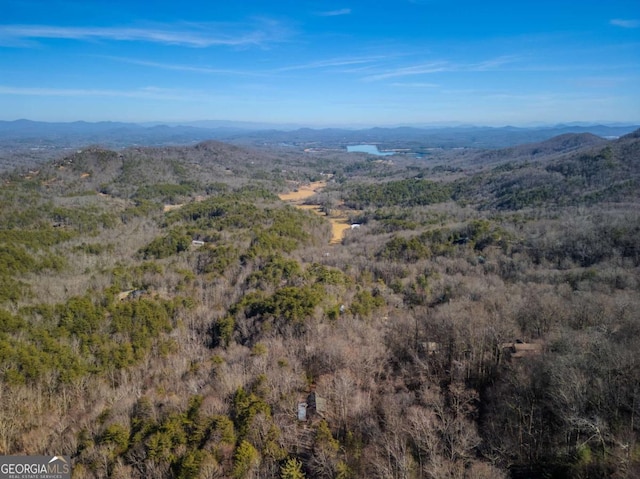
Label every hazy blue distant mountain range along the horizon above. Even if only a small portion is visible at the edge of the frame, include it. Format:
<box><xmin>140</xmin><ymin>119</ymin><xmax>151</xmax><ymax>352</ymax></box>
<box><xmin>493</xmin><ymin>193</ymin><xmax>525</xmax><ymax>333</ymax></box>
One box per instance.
<box><xmin>0</xmin><ymin>120</ymin><xmax>639</xmax><ymax>149</ymax></box>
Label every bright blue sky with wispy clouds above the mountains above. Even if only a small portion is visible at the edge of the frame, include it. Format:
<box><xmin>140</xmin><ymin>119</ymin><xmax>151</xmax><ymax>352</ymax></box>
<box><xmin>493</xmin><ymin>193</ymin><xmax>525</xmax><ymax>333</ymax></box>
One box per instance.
<box><xmin>0</xmin><ymin>0</ymin><xmax>640</xmax><ymax>126</ymax></box>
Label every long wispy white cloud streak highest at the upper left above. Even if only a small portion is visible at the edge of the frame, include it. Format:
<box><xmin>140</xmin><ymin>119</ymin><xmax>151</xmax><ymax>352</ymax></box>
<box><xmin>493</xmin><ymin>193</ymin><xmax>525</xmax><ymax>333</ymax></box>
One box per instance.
<box><xmin>0</xmin><ymin>21</ymin><xmax>285</xmax><ymax>48</ymax></box>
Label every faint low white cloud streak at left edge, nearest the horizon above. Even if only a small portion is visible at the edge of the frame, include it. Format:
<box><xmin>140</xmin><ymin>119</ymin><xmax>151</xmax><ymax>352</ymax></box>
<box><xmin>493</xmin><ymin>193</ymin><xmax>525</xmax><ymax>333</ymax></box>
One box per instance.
<box><xmin>0</xmin><ymin>85</ymin><xmax>189</xmax><ymax>100</ymax></box>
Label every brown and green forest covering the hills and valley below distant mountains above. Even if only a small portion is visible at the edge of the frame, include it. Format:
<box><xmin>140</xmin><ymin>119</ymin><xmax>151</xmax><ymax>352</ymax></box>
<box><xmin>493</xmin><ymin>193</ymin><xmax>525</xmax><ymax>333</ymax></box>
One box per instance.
<box><xmin>0</xmin><ymin>131</ymin><xmax>640</xmax><ymax>479</ymax></box>
